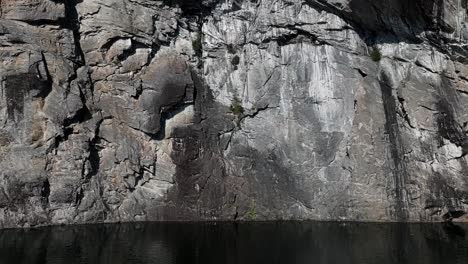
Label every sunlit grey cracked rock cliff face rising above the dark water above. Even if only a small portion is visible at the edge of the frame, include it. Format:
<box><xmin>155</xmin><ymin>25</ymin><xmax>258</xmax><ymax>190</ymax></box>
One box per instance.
<box><xmin>0</xmin><ymin>0</ymin><xmax>468</xmax><ymax>227</ymax></box>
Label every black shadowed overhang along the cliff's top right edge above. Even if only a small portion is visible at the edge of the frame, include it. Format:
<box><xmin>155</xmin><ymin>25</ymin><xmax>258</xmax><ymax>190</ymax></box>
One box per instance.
<box><xmin>305</xmin><ymin>0</ymin><xmax>446</xmax><ymax>45</ymax></box>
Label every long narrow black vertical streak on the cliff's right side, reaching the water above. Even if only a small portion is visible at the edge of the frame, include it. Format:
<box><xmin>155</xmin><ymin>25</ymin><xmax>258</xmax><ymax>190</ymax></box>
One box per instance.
<box><xmin>379</xmin><ymin>73</ymin><xmax>408</xmax><ymax>221</ymax></box>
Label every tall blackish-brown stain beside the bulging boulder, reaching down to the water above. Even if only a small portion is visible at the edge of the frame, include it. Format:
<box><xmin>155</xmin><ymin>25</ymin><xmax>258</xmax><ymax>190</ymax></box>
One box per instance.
<box><xmin>163</xmin><ymin>69</ymin><xmax>226</xmax><ymax>220</ymax></box>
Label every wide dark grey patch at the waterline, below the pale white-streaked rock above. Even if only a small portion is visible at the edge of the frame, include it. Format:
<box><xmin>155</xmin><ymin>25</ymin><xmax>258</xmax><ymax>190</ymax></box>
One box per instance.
<box><xmin>229</xmin><ymin>141</ymin><xmax>314</xmax><ymax>220</ymax></box>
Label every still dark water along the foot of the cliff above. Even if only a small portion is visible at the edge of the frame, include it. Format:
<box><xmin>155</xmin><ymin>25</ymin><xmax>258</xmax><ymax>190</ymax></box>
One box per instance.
<box><xmin>0</xmin><ymin>222</ymin><xmax>468</xmax><ymax>264</ymax></box>
